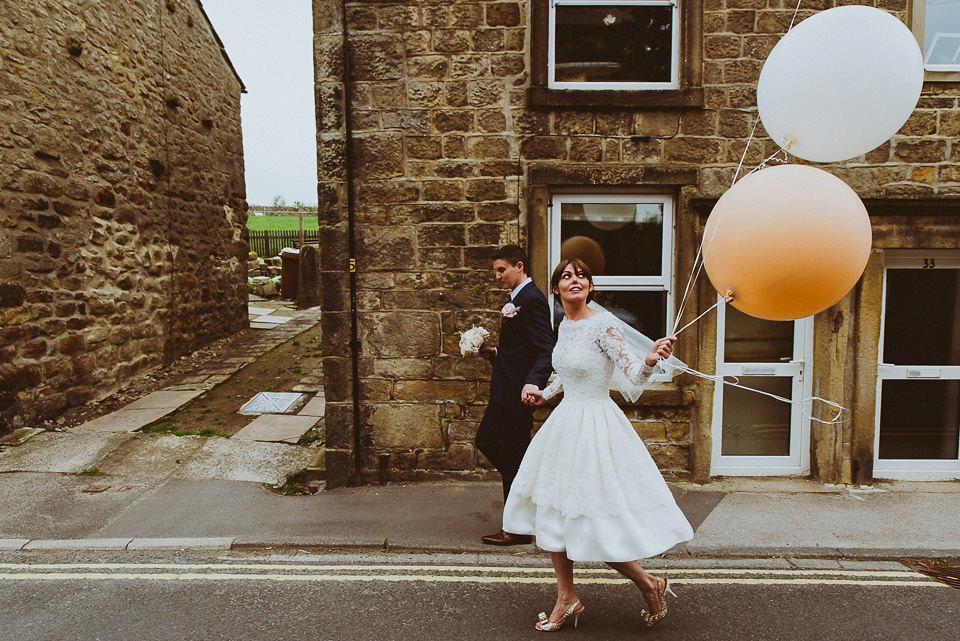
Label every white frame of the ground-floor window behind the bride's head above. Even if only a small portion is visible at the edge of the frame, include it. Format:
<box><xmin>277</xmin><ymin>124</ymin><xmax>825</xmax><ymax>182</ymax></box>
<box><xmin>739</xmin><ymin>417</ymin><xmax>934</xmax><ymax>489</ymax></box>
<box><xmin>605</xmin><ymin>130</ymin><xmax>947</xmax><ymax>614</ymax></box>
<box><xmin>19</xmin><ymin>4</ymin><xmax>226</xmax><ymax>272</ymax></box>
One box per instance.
<box><xmin>548</xmin><ymin>193</ymin><xmax>676</xmax><ymax>381</ymax></box>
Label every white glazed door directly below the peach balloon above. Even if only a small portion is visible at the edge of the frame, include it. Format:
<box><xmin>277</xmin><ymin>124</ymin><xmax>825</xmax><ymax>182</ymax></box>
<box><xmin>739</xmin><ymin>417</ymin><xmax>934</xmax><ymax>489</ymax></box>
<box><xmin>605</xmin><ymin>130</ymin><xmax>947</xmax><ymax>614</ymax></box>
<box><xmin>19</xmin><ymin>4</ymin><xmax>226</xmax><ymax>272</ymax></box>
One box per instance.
<box><xmin>710</xmin><ymin>304</ymin><xmax>813</xmax><ymax>476</ymax></box>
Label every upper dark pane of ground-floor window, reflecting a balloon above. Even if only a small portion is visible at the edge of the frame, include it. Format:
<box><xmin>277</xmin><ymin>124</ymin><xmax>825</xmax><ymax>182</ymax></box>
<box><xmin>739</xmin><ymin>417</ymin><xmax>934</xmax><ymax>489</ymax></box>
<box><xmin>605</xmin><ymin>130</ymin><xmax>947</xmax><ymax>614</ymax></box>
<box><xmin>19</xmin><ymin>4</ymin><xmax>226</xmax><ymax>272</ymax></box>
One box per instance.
<box><xmin>560</xmin><ymin>203</ymin><xmax>663</xmax><ymax>276</ymax></box>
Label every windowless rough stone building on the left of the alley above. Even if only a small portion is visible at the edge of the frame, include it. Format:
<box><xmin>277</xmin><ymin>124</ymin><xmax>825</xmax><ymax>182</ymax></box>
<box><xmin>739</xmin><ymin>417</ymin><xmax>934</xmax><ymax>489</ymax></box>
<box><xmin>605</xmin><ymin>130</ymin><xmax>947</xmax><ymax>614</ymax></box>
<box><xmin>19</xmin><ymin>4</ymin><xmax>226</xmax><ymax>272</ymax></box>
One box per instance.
<box><xmin>0</xmin><ymin>0</ymin><xmax>247</xmax><ymax>433</ymax></box>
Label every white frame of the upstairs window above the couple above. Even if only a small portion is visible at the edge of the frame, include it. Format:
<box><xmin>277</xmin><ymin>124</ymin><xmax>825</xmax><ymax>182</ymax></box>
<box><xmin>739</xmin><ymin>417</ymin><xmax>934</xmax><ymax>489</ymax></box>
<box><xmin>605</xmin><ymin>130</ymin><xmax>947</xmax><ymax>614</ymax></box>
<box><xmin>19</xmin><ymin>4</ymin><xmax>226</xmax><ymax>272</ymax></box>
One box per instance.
<box><xmin>547</xmin><ymin>0</ymin><xmax>681</xmax><ymax>91</ymax></box>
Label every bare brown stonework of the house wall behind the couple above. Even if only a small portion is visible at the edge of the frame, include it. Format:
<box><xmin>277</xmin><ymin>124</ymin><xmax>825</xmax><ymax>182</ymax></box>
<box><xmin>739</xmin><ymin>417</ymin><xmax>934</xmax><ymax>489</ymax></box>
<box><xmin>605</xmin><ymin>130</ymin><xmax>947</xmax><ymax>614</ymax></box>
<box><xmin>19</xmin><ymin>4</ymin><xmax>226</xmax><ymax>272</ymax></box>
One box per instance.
<box><xmin>314</xmin><ymin>0</ymin><xmax>960</xmax><ymax>480</ymax></box>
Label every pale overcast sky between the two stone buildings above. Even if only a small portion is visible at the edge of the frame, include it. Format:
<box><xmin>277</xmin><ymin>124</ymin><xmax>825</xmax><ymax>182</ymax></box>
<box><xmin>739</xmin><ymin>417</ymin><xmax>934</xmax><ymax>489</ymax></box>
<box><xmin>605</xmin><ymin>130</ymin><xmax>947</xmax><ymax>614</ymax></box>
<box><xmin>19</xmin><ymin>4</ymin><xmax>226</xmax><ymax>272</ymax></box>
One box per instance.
<box><xmin>201</xmin><ymin>0</ymin><xmax>317</xmax><ymax>205</ymax></box>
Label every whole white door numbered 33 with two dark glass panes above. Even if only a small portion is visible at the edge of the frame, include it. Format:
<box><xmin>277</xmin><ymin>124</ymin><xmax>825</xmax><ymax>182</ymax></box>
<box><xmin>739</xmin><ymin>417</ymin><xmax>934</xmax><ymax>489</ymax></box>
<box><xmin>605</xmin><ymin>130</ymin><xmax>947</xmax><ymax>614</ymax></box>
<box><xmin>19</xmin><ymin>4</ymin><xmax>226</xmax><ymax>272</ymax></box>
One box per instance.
<box><xmin>873</xmin><ymin>251</ymin><xmax>960</xmax><ymax>480</ymax></box>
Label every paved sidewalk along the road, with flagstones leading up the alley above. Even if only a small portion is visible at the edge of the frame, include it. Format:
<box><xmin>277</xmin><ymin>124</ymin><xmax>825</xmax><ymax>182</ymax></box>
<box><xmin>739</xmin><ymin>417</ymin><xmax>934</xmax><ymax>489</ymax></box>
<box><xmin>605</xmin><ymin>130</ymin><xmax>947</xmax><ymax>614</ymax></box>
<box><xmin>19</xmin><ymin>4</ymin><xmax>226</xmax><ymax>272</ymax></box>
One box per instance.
<box><xmin>0</xmin><ymin>303</ymin><xmax>960</xmax><ymax>559</ymax></box>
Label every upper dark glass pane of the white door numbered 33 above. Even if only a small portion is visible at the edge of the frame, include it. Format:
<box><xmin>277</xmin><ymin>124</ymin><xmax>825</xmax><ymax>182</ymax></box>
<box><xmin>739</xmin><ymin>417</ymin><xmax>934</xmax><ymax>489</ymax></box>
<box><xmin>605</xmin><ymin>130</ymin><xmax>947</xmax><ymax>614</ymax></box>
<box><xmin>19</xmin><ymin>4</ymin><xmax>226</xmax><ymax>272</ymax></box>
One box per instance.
<box><xmin>883</xmin><ymin>268</ymin><xmax>960</xmax><ymax>365</ymax></box>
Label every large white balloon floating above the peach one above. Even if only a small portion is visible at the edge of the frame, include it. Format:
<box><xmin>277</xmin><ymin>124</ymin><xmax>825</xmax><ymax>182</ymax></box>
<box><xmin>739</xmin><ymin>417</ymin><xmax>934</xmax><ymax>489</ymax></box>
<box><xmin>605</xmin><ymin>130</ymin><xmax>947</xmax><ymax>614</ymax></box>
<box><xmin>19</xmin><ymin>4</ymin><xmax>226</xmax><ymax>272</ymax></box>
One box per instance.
<box><xmin>757</xmin><ymin>6</ymin><xmax>923</xmax><ymax>162</ymax></box>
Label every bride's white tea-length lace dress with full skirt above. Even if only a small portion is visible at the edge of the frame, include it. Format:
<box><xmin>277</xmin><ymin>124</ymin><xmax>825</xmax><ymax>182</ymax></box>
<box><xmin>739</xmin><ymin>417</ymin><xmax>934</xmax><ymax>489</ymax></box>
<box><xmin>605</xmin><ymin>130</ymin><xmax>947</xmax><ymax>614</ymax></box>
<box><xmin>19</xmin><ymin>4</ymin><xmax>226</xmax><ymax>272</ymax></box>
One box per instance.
<box><xmin>503</xmin><ymin>312</ymin><xmax>693</xmax><ymax>561</ymax></box>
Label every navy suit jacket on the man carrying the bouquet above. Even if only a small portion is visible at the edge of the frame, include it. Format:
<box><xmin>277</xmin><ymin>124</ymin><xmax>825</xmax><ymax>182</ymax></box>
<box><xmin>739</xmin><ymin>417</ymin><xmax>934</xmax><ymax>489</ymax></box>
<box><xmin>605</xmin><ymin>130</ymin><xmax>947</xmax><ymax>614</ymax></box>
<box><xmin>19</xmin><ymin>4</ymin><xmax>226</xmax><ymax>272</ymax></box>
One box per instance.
<box><xmin>490</xmin><ymin>281</ymin><xmax>556</xmax><ymax>408</ymax></box>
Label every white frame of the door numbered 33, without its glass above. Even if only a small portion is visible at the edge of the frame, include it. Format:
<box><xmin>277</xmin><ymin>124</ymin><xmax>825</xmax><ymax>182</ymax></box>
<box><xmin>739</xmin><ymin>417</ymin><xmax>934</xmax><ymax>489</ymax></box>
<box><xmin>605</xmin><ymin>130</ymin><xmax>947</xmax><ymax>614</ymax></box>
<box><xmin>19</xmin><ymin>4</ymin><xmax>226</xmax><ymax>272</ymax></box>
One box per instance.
<box><xmin>873</xmin><ymin>250</ymin><xmax>960</xmax><ymax>481</ymax></box>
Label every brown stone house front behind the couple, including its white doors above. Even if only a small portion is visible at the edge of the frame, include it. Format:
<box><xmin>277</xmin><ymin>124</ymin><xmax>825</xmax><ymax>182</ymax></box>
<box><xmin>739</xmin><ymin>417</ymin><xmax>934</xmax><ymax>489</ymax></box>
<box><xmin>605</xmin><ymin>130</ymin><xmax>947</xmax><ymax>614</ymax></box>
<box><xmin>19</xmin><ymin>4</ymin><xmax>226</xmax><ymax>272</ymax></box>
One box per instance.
<box><xmin>314</xmin><ymin>0</ymin><xmax>960</xmax><ymax>484</ymax></box>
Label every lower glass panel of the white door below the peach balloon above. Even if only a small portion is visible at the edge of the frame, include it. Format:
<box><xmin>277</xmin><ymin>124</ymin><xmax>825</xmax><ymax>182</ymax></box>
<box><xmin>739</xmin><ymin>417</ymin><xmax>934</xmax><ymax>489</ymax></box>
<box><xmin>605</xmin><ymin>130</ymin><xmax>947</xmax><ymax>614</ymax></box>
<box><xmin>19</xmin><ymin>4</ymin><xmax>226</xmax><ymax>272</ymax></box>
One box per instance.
<box><xmin>720</xmin><ymin>376</ymin><xmax>793</xmax><ymax>456</ymax></box>
